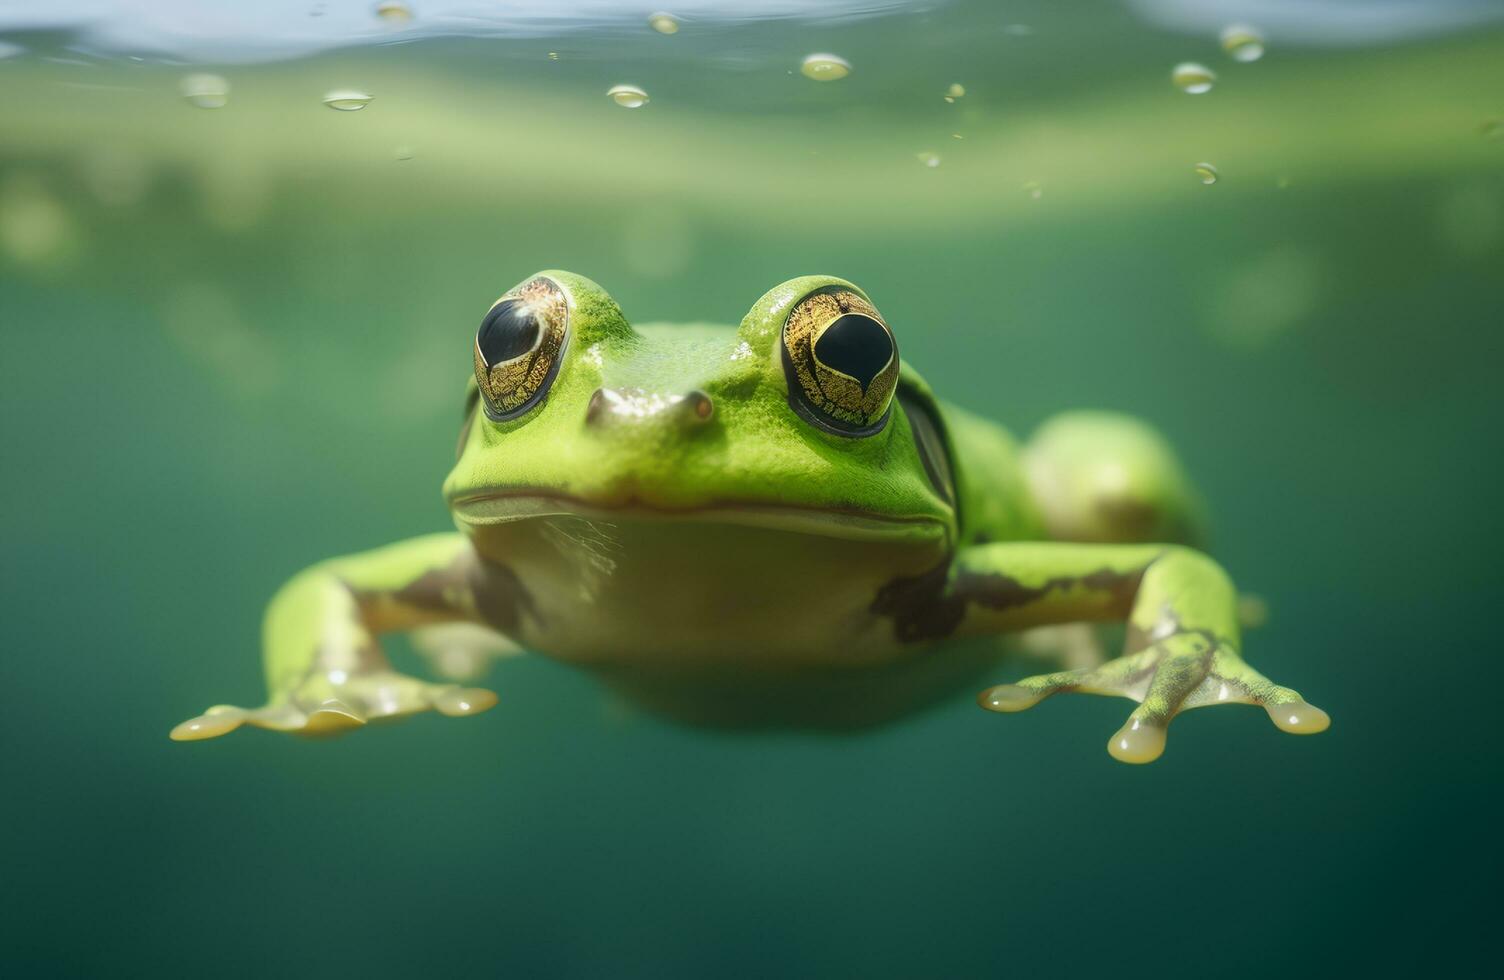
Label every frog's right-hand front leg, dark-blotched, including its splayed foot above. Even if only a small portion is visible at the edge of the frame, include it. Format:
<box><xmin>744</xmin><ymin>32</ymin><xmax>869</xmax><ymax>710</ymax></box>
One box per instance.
<box><xmin>878</xmin><ymin>543</ymin><xmax>1330</xmax><ymax>762</ymax></box>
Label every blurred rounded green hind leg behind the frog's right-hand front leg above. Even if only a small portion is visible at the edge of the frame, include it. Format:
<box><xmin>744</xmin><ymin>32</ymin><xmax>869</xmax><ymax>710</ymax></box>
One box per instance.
<box><xmin>1024</xmin><ymin>412</ymin><xmax>1206</xmax><ymax>547</ymax></box>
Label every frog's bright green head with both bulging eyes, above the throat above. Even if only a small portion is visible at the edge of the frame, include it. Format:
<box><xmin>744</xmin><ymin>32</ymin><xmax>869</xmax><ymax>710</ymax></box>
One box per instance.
<box><xmin>444</xmin><ymin>271</ymin><xmax>955</xmax><ymax>547</ymax></box>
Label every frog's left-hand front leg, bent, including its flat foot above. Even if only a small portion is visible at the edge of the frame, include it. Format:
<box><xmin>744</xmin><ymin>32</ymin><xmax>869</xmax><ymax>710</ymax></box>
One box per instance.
<box><xmin>171</xmin><ymin>534</ymin><xmax>526</xmax><ymax>741</ymax></box>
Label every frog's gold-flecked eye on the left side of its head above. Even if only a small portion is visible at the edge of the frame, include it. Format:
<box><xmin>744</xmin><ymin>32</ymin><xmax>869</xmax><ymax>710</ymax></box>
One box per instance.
<box><xmin>475</xmin><ymin>277</ymin><xmax>569</xmax><ymax>422</ymax></box>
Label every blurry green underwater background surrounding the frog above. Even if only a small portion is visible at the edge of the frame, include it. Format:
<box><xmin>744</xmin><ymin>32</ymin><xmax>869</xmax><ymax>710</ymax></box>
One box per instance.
<box><xmin>0</xmin><ymin>0</ymin><xmax>1504</xmax><ymax>977</ymax></box>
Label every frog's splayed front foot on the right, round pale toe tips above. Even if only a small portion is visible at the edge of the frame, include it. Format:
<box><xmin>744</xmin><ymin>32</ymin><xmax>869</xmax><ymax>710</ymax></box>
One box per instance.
<box><xmin>978</xmin><ymin>633</ymin><xmax>1331</xmax><ymax>762</ymax></box>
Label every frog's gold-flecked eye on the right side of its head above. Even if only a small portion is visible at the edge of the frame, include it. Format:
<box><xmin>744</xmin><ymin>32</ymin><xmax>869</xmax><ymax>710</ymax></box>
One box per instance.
<box><xmin>784</xmin><ymin>287</ymin><xmax>898</xmax><ymax>436</ymax></box>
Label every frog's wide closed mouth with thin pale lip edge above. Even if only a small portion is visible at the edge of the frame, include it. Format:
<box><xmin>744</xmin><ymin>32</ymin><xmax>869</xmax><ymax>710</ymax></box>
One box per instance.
<box><xmin>450</xmin><ymin>490</ymin><xmax>949</xmax><ymax>541</ymax></box>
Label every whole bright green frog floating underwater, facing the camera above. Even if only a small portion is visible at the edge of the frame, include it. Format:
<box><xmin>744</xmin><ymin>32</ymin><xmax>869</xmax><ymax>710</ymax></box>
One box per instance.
<box><xmin>170</xmin><ymin>271</ymin><xmax>1330</xmax><ymax>764</ymax></box>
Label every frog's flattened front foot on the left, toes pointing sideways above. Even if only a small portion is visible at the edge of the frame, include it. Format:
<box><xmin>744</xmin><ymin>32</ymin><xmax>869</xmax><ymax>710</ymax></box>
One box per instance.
<box><xmin>171</xmin><ymin>666</ymin><xmax>496</xmax><ymax>741</ymax></box>
